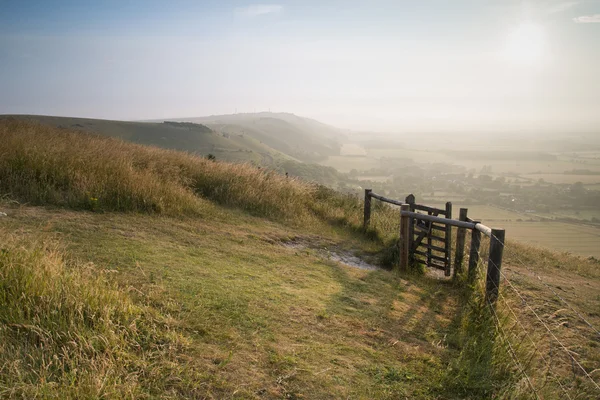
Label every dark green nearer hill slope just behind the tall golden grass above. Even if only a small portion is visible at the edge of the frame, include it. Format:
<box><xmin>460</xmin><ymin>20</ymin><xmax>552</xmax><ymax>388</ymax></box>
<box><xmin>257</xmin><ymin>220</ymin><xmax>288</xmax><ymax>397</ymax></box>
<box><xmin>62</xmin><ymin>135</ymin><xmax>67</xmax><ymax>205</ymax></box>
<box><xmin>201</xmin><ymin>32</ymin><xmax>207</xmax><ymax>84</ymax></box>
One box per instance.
<box><xmin>0</xmin><ymin>115</ymin><xmax>293</xmax><ymax>164</ymax></box>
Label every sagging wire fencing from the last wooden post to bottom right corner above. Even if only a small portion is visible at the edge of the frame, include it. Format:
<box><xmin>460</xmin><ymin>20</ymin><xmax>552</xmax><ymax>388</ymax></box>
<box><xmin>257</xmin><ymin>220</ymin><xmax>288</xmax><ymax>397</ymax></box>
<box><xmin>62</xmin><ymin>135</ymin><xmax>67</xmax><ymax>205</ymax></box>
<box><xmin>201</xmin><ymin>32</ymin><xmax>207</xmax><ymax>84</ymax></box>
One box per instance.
<box><xmin>472</xmin><ymin>233</ymin><xmax>600</xmax><ymax>399</ymax></box>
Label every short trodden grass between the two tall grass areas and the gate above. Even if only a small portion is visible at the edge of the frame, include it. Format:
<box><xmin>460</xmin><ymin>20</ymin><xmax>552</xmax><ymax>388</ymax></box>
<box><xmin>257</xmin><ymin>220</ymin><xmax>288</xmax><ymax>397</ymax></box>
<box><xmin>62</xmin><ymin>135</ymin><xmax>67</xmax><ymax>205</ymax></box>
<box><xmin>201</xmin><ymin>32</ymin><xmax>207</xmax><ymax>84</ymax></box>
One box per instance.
<box><xmin>0</xmin><ymin>203</ymin><xmax>457</xmax><ymax>398</ymax></box>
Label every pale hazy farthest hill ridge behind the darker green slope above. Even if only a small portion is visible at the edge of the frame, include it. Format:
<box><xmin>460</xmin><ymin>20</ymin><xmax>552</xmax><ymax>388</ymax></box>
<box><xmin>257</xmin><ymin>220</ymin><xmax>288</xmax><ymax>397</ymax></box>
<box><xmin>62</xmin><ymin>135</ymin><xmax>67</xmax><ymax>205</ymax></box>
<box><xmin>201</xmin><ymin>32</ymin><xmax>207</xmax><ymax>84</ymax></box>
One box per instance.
<box><xmin>164</xmin><ymin>112</ymin><xmax>344</xmax><ymax>162</ymax></box>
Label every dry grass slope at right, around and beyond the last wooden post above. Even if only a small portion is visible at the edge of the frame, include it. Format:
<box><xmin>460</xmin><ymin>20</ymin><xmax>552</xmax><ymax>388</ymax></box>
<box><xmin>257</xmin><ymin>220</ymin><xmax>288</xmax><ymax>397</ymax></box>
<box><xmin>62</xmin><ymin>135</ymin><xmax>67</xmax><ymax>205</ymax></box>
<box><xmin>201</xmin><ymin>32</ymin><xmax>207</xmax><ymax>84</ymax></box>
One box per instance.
<box><xmin>449</xmin><ymin>233</ymin><xmax>600</xmax><ymax>399</ymax></box>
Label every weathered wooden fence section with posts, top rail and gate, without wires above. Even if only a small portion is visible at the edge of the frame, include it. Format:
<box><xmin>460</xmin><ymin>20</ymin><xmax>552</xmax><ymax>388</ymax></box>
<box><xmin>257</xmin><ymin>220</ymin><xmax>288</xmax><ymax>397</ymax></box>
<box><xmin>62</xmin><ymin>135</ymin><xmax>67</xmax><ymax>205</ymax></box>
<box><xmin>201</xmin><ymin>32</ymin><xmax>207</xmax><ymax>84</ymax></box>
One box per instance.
<box><xmin>363</xmin><ymin>189</ymin><xmax>505</xmax><ymax>304</ymax></box>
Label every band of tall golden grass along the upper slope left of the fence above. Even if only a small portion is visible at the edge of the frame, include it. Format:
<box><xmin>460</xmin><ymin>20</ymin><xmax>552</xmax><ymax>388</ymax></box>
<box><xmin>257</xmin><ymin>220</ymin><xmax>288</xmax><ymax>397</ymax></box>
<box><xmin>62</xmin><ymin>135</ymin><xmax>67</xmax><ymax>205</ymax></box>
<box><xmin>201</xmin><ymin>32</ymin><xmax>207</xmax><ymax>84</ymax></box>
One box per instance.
<box><xmin>0</xmin><ymin>119</ymin><xmax>359</xmax><ymax>223</ymax></box>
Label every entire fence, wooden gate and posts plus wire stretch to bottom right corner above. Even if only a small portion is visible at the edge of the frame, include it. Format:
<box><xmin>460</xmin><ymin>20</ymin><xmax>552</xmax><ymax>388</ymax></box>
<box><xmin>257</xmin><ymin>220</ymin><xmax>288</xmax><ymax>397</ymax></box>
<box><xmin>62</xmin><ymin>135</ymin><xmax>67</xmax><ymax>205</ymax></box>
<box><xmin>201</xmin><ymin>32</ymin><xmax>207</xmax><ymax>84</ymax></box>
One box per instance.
<box><xmin>364</xmin><ymin>189</ymin><xmax>600</xmax><ymax>399</ymax></box>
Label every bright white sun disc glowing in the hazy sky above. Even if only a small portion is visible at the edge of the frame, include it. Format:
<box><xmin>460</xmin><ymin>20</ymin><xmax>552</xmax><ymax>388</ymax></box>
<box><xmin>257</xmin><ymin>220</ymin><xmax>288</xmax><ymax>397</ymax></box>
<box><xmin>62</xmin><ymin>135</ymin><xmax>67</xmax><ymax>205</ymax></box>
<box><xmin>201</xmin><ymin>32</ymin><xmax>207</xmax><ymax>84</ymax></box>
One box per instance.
<box><xmin>504</xmin><ymin>22</ymin><xmax>546</xmax><ymax>65</ymax></box>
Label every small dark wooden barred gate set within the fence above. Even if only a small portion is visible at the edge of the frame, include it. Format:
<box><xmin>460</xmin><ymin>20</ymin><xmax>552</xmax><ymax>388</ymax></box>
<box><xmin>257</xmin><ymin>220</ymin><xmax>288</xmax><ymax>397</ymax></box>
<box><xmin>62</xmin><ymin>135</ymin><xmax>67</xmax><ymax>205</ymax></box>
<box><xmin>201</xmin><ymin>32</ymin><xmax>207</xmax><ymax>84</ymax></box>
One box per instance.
<box><xmin>406</xmin><ymin>194</ymin><xmax>452</xmax><ymax>276</ymax></box>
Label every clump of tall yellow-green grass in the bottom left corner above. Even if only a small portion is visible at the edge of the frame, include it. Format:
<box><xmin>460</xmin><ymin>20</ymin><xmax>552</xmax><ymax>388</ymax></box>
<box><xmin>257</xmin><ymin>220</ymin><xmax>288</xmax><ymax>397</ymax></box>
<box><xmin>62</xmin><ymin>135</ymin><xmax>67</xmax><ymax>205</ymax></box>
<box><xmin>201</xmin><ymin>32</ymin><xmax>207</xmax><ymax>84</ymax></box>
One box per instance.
<box><xmin>0</xmin><ymin>235</ymin><xmax>207</xmax><ymax>399</ymax></box>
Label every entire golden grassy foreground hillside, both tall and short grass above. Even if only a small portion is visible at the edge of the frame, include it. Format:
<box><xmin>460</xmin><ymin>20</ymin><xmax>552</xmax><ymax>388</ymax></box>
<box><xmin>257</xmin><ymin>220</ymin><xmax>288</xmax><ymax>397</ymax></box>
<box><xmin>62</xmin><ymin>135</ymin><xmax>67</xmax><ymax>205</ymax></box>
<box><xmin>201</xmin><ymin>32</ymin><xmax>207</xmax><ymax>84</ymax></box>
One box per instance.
<box><xmin>0</xmin><ymin>120</ymin><xmax>600</xmax><ymax>399</ymax></box>
